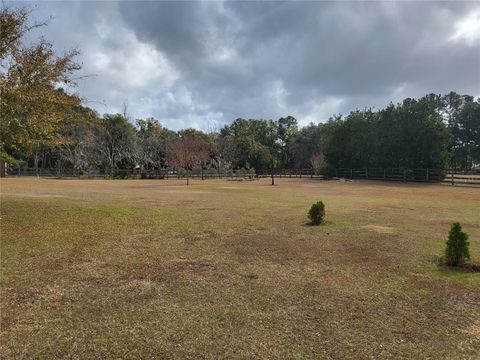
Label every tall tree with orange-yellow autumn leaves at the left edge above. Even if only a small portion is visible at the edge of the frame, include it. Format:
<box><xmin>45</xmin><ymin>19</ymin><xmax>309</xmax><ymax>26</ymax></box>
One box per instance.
<box><xmin>0</xmin><ymin>5</ymin><xmax>80</xmax><ymax>166</ymax></box>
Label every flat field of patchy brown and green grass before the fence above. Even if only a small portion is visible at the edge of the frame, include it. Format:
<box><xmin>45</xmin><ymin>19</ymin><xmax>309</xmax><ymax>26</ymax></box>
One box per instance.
<box><xmin>0</xmin><ymin>178</ymin><xmax>480</xmax><ymax>359</ymax></box>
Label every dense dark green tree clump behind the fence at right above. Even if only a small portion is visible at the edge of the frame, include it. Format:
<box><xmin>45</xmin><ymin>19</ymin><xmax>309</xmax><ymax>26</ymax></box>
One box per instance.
<box><xmin>322</xmin><ymin>93</ymin><xmax>480</xmax><ymax>168</ymax></box>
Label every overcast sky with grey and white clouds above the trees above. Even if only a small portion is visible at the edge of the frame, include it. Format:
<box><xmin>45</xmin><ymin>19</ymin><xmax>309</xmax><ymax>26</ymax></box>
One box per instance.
<box><xmin>20</xmin><ymin>1</ymin><xmax>480</xmax><ymax>130</ymax></box>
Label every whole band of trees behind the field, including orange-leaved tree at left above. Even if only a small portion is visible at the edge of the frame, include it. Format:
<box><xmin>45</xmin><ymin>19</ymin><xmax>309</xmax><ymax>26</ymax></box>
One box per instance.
<box><xmin>0</xmin><ymin>7</ymin><xmax>480</xmax><ymax>172</ymax></box>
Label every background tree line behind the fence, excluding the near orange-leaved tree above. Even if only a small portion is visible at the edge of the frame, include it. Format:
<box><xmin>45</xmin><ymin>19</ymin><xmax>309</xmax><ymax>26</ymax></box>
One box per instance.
<box><xmin>2</xmin><ymin>93</ymin><xmax>480</xmax><ymax>172</ymax></box>
